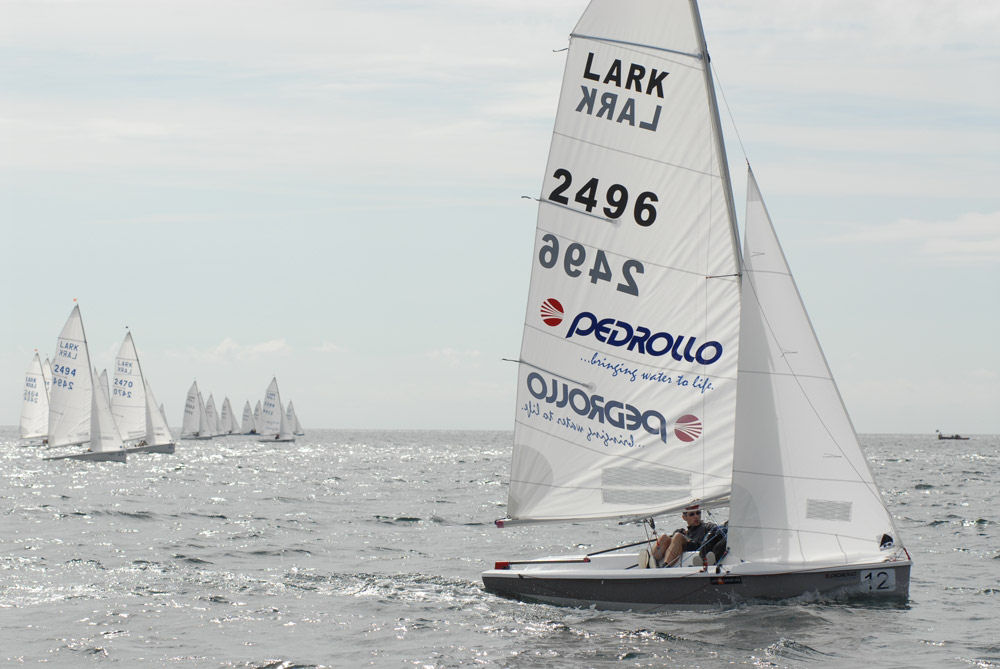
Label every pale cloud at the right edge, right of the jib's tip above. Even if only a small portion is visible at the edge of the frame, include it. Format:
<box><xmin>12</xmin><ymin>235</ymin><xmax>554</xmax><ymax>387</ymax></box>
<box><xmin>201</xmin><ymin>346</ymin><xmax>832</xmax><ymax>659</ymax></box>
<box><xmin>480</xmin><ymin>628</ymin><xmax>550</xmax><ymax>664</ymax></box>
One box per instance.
<box><xmin>828</xmin><ymin>211</ymin><xmax>1000</xmax><ymax>266</ymax></box>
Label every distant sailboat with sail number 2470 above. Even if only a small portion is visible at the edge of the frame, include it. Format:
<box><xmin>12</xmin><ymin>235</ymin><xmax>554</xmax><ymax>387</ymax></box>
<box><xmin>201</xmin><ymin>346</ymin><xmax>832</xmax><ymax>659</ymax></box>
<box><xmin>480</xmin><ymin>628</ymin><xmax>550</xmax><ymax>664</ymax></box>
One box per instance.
<box><xmin>111</xmin><ymin>332</ymin><xmax>174</xmax><ymax>453</ymax></box>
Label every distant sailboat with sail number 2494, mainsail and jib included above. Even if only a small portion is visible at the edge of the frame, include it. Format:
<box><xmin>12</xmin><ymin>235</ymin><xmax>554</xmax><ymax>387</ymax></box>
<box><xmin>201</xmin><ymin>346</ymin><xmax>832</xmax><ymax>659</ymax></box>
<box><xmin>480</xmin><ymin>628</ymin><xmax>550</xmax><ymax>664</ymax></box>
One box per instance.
<box><xmin>45</xmin><ymin>305</ymin><xmax>125</xmax><ymax>462</ymax></box>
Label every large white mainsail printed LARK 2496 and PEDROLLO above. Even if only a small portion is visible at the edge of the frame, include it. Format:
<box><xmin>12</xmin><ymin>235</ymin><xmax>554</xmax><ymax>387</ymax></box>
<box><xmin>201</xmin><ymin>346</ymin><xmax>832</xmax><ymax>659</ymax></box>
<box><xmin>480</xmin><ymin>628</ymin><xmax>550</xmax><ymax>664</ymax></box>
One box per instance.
<box><xmin>508</xmin><ymin>0</ymin><xmax>739</xmax><ymax>521</ymax></box>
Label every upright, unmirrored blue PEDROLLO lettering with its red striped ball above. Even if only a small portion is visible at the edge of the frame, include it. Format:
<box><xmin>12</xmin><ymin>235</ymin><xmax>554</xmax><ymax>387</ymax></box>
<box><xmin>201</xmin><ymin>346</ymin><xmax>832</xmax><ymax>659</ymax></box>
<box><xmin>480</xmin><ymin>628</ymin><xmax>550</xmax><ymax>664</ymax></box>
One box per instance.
<box><xmin>541</xmin><ymin>298</ymin><xmax>722</xmax><ymax>365</ymax></box>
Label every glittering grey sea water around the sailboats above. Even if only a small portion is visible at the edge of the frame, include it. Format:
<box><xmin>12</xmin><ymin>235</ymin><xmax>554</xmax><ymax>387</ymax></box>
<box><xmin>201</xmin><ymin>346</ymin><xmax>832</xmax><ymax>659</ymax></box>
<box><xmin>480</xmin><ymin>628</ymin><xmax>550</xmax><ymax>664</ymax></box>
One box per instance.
<box><xmin>0</xmin><ymin>428</ymin><xmax>1000</xmax><ymax>668</ymax></box>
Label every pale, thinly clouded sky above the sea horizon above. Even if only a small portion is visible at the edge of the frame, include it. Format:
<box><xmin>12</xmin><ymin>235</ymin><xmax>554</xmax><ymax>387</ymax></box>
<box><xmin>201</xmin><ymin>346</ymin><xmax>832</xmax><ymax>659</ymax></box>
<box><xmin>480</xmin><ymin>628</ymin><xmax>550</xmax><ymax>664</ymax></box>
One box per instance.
<box><xmin>0</xmin><ymin>0</ymin><xmax>1000</xmax><ymax>433</ymax></box>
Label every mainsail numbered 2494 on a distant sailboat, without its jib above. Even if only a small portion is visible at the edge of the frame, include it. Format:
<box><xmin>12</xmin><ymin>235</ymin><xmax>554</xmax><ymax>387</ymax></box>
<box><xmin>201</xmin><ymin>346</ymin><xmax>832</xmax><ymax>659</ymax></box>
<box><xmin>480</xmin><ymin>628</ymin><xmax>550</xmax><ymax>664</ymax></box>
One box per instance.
<box><xmin>49</xmin><ymin>305</ymin><xmax>94</xmax><ymax>446</ymax></box>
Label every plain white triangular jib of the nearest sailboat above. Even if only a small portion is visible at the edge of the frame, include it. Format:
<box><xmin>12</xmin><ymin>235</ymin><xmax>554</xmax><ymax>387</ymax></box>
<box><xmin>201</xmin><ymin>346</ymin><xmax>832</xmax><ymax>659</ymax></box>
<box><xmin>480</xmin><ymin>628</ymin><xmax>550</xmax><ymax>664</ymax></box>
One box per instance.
<box><xmin>729</xmin><ymin>172</ymin><xmax>898</xmax><ymax>566</ymax></box>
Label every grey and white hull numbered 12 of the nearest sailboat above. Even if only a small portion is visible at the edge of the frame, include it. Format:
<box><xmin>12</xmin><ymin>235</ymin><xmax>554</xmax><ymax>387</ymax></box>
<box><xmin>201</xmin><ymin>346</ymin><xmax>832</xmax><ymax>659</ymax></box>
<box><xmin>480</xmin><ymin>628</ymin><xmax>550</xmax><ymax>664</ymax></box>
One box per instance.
<box><xmin>483</xmin><ymin>554</ymin><xmax>912</xmax><ymax>611</ymax></box>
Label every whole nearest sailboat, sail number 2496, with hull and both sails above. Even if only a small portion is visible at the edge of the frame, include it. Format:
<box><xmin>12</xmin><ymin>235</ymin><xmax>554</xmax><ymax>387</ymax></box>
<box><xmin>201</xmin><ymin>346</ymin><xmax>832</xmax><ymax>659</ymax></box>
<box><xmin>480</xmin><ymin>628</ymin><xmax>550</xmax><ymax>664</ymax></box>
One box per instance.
<box><xmin>483</xmin><ymin>0</ymin><xmax>911</xmax><ymax>610</ymax></box>
